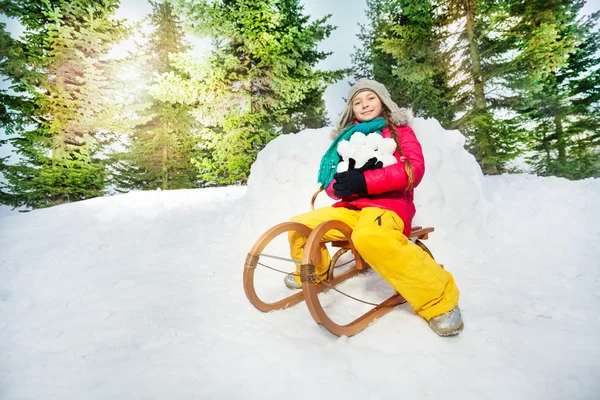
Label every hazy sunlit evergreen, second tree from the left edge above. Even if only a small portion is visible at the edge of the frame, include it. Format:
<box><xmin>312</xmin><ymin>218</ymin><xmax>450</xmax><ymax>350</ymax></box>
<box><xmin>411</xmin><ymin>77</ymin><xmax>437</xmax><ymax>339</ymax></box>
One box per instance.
<box><xmin>113</xmin><ymin>2</ymin><xmax>200</xmax><ymax>191</ymax></box>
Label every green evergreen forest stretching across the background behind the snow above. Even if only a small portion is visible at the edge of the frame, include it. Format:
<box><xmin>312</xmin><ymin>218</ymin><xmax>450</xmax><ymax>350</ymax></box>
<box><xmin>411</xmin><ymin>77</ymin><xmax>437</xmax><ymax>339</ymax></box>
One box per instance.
<box><xmin>0</xmin><ymin>0</ymin><xmax>600</xmax><ymax>209</ymax></box>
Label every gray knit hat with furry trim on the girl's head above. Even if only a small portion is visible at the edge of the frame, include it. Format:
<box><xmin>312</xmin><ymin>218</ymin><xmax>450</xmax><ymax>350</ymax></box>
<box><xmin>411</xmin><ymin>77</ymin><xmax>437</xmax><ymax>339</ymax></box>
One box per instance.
<box><xmin>331</xmin><ymin>78</ymin><xmax>412</xmax><ymax>139</ymax></box>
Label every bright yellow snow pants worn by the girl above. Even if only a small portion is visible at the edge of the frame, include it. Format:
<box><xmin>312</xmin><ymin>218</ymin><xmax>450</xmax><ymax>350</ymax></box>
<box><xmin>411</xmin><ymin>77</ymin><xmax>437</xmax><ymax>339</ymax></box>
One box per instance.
<box><xmin>288</xmin><ymin>207</ymin><xmax>460</xmax><ymax>321</ymax></box>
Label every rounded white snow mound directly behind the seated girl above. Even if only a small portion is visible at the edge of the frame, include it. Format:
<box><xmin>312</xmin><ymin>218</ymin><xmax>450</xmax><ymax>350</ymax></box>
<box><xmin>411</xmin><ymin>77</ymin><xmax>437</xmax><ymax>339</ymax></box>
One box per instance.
<box><xmin>245</xmin><ymin>118</ymin><xmax>489</xmax><ymax>239</ymax></box>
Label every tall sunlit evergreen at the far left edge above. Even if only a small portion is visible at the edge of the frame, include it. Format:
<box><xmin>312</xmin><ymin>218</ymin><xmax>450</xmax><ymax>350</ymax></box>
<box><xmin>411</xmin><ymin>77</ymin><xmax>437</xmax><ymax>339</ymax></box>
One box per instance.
<box><xmin>0</xmin><ymin>0</ymin><xmax>126</xmax><ymax>208</ymax></box>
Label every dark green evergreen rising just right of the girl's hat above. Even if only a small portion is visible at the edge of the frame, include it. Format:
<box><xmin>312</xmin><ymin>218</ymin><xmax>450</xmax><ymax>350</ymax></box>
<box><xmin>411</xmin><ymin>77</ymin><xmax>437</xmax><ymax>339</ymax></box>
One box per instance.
<box><xmin>353</xmin><ymin>0</ymin><xmax>456</xmax><ymax>126</ymax></box>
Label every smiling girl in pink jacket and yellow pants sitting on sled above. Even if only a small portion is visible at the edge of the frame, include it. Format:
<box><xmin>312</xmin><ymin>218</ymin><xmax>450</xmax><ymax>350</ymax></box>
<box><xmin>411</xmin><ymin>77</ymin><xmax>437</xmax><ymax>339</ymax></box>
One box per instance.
<box><xmin>285</xmin><ymin>78</ymin><xmax>463</xmax><ymax>336</ymax></box>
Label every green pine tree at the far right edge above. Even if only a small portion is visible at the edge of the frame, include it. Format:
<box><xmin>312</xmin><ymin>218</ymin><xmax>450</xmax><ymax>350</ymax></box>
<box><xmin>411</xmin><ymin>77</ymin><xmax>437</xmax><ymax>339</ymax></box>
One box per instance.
<box><xmin>510</xmin><ymin>0</ymin><xmax>600</xmax><ymax>179</ymax></box>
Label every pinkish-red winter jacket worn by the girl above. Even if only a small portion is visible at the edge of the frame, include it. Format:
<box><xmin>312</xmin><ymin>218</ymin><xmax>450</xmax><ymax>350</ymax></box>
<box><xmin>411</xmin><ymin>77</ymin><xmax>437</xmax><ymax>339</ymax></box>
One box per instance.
<box><xmin>325</xmin><ymin>125</ymin><xmax>425</xmax><ymax>237</ymax></box>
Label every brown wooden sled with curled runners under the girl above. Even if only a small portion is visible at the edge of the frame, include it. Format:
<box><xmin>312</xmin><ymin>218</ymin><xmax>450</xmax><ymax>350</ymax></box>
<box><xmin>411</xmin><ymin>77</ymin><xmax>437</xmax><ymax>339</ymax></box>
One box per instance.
<box><xmin>244</xmin><ymin>220</ymin><xmax>434</xmax><ymax>336</ymax></box>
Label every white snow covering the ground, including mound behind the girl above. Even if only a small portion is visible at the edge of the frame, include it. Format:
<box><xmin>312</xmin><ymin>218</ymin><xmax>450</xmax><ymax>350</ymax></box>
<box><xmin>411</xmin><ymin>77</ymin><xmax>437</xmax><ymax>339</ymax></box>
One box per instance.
<box><xmin>0</xmin><ymin>119</ymin><xmax>600</xmax><ymax>400</ymax></box>
